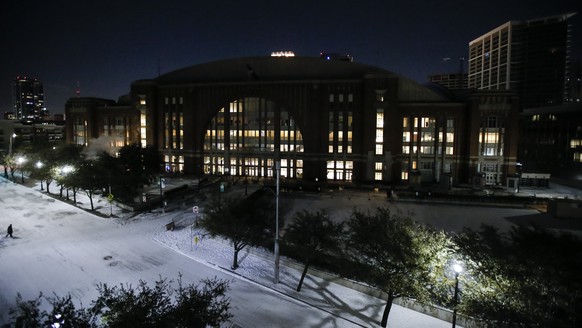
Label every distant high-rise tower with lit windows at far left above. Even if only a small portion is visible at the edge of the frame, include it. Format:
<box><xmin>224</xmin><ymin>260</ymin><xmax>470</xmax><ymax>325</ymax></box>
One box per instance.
<box><xmin>12</xmin><ymin>76</ymin><xmax>48</xmax><ymax>120</ymax></box>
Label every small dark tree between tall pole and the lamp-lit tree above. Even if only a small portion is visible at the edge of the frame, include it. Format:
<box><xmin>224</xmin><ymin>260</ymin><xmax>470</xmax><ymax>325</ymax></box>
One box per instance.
<box><xmin>283</xmin><ymin>211</ymin><xmax>344</xmax><ymax>292</ymax></box>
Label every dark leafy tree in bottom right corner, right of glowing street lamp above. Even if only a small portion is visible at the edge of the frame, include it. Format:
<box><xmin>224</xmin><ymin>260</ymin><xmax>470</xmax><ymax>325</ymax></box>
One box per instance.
<box><xmin>456</xmin><ymin>226</ymin><xmax>582</xmax><ymax>327</ymax></box>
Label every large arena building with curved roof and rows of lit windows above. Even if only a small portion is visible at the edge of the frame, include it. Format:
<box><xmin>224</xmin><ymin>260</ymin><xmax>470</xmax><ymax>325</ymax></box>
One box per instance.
<box><xmin>67</xmin><ymin>57</ymin><xmax>519</xmax><ymax>185</ymax></box>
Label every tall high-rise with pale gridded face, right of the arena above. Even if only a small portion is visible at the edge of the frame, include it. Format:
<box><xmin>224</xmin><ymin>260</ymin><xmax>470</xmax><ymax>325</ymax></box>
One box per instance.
<box><xmin>469</xmin><ymin>13</ymin><xmax>575</xmax><ymax>109</ymax></box>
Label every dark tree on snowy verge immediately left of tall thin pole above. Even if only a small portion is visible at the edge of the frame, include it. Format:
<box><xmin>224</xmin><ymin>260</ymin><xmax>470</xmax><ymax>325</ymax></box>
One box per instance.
<box><xmin>199</xmin><ymin>190</ymin><xmax>282</xmax><ymax>270</ymax></box>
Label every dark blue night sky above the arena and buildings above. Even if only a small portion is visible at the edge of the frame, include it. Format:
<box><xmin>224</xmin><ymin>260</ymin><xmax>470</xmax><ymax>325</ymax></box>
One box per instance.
<box><xmin>0</xmin><ymin>0</ymin><xmax>582</xmax><ymax>113</ymax></box>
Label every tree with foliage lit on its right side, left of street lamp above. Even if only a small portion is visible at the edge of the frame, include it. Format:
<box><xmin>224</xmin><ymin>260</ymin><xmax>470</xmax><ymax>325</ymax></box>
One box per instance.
<box><xmin>347</xmin><ymin>208</ymin><xmax>449</xmax><ymax>327</ymax></box>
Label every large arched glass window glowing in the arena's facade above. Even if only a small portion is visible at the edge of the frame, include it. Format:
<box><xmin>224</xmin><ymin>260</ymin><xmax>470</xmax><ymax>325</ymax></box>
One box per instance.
<box><xmin>204</xmin><ymin>97</ymin><xmax>304</xmax><ymax>178</ymax></box>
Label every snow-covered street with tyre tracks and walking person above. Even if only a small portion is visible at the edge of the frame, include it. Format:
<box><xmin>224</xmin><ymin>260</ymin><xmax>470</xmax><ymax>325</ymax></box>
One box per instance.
<box><xmin>0</xmin><ymin>180</ymin><xmax>450</xmax><ymax>328</ymax></box>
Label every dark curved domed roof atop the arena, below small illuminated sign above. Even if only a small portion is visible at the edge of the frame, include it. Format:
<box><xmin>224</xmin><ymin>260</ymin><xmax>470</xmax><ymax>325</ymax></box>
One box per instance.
<box><xmin>156</xmin><ymin>56</ymin><xmax>393</xmax><ymax>84</ymax></box>
